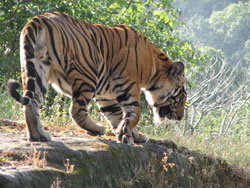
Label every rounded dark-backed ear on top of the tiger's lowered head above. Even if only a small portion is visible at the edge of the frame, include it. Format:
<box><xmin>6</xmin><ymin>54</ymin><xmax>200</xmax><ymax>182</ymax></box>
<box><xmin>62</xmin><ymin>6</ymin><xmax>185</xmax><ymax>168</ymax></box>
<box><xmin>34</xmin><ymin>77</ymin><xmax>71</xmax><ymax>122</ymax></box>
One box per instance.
<box><xmin>169</xmin><ymin>62</ymin><xmax>185</xmax><ymax>84</ymax></box>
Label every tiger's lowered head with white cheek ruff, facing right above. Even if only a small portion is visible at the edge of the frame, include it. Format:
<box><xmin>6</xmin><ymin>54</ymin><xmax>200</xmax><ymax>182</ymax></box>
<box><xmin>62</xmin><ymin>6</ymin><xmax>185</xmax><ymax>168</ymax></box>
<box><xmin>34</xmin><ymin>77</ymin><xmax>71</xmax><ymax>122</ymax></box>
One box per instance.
<box><xmin>145</xmin><ymin>62</ymin><xmax>187</xmax><ymax>122</ymax></box>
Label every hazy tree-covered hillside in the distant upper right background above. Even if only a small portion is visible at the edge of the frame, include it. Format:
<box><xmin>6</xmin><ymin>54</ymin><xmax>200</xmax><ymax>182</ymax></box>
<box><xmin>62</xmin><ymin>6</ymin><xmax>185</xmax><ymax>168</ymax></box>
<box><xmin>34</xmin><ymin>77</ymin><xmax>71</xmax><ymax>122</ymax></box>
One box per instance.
<box><xmin>176</xmin><ymin>0</ymin><xmax>250</xmax><ymax>67</ymax></box>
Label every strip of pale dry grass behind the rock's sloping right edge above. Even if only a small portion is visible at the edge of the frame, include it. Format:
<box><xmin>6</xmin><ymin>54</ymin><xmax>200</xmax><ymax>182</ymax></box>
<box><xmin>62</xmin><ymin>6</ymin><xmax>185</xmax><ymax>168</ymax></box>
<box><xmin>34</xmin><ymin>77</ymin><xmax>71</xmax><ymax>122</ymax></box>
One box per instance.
<box><xmin>146</xmin><ymin>125</ymin><xmax>250</xmax><ymax>171</ymax></box>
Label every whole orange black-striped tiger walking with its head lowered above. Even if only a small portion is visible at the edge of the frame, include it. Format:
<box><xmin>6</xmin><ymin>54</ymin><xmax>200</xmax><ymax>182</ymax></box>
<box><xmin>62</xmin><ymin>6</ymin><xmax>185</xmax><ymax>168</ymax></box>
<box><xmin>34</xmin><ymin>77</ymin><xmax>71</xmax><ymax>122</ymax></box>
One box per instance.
<box><xmin>8</xmin><ymin>12</ymin><xmax>186</xmax><ymax>144</ymax></box>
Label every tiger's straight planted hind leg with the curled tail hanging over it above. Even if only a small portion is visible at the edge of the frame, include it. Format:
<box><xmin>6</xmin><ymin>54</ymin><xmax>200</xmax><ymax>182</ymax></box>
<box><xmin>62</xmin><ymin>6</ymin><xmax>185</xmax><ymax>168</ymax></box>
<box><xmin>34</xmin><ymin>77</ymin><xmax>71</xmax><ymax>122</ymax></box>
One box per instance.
<box><xmin>8</xmin><ymin>41</ymin><xmax>51</xmax><ymax>141</ymax></box>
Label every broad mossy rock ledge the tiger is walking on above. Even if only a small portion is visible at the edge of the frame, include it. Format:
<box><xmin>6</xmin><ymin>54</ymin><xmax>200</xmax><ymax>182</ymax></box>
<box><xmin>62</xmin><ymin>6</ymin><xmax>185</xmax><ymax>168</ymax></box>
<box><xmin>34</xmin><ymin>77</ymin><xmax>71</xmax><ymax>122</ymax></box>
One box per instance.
<box><xmin>0</xmin><ymin>125</ymin><xmax>249</xmax><ymax>188</ymax></box>
